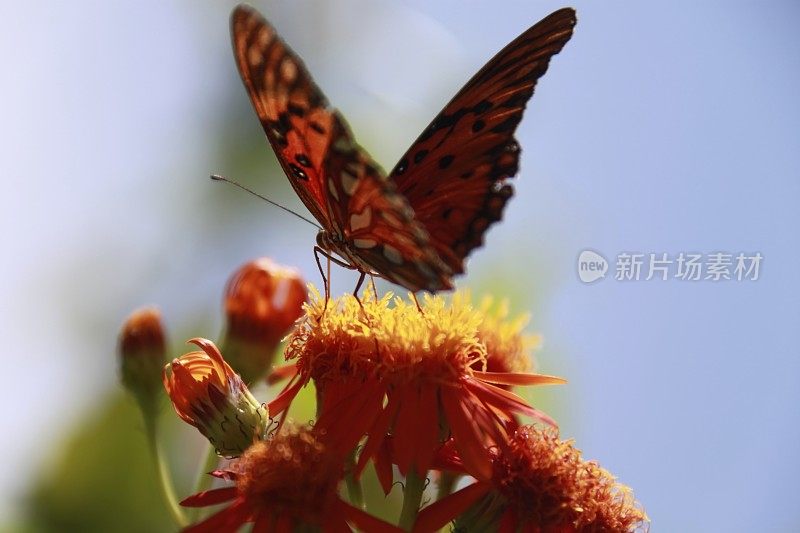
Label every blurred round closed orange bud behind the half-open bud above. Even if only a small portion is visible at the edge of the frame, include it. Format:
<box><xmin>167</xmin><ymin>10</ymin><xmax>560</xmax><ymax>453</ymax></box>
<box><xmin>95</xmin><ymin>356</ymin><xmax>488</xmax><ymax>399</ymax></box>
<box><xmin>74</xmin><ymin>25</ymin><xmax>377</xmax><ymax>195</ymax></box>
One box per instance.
<box><xmin>222</xmin><ymin>258</ymin><xmax>307</xmax><ymax>383</ymax></box>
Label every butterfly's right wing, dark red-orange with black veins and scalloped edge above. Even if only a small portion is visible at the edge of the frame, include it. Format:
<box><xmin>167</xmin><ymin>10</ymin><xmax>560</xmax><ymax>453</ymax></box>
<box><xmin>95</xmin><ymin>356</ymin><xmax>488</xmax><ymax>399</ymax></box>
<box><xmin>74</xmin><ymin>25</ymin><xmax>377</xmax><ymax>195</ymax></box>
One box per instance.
<box><xmin>390</xmin><ymin>8</ymin><xmax>576</xmax><ymax>273</ymax></box>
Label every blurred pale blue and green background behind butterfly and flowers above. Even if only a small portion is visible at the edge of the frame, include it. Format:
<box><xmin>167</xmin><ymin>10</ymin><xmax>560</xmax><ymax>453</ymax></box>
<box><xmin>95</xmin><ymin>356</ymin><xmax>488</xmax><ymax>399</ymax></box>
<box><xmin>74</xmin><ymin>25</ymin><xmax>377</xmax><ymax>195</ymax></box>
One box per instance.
<box><xmin>0</xmin><ymin>0</ymin><xmax>800</xmax><ymax>532</ymax></box>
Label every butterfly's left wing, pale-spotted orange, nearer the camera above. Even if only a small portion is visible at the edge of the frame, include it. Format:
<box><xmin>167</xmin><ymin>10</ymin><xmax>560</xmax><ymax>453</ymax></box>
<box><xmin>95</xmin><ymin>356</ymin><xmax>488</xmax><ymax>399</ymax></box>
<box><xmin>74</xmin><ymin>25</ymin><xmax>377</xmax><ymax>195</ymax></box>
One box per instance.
<box><xmin>231</xmin><ymin>6</ymin><xmax>451</xmax><ymax>291</ymax></box>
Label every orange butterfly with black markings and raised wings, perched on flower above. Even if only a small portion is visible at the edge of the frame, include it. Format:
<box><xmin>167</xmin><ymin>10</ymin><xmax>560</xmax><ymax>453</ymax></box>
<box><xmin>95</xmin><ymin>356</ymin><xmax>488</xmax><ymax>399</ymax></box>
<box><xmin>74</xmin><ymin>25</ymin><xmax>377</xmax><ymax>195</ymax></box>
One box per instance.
<box><xmin>231</xmin><ymin>5</ymin><xmax>576</xmax><ymax>293</ymax></box>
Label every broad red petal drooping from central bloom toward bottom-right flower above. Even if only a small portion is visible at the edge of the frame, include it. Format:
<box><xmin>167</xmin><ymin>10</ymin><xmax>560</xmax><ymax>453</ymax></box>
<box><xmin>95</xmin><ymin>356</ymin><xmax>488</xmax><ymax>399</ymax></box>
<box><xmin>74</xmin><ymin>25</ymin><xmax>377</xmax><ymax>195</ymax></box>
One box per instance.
<box><xmin>441</xmin><ymin>388</ymin><xmax>492</xmax><ymax>480</ymax></box>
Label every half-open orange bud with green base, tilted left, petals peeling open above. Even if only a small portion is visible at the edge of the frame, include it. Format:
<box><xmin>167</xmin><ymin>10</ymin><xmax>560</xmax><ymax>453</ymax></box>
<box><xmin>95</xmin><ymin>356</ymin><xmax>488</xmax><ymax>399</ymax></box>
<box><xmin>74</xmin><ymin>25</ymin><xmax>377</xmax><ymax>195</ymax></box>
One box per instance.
<box><xmin>163</xmin><ymin>338</ymin><xmax>266</xmax><ymax>457</ymax></box>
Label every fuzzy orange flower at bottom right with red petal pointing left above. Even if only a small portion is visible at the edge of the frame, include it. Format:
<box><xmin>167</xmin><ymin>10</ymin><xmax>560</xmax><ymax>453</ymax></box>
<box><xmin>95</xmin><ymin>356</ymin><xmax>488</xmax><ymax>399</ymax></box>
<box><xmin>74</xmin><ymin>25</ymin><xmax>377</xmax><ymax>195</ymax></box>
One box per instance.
<box><xmin>414</xmin><ymin>426</ymin><xmax>649</xmax><ymax>533</ymax></box>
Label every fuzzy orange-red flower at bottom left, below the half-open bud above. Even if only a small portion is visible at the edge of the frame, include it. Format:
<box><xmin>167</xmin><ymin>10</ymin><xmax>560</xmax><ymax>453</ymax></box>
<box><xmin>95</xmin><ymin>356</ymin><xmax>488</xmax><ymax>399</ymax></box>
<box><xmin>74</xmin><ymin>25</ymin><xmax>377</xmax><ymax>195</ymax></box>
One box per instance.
<box><xmin>181</xmin><ymin>427</ymin><xmax>400</xmax><ymax>533</ymax></box>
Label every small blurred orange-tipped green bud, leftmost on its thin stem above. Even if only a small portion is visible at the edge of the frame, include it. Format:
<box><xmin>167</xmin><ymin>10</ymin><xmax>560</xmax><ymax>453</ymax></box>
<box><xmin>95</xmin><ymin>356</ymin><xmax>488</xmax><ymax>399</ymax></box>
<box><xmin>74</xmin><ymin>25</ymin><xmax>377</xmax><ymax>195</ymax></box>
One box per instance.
<box><xmin>118</xmin><ymin>307</ymin><xmax>166</xmax><ymax>418</ymax></box>
